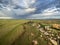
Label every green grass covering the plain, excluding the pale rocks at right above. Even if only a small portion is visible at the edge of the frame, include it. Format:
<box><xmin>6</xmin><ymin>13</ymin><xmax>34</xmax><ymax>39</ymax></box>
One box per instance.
<box><xmin>0</xmin><ymin>20</ymin><xmax>60</xmax><ymax>45</ymax></box>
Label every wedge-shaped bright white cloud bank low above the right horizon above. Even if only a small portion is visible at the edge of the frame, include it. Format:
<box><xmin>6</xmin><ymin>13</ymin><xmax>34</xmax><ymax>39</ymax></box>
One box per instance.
<box><xmin>27</xmin><ymin>7</ymin><xmax>60</xmax><ymax>19</ymax></box>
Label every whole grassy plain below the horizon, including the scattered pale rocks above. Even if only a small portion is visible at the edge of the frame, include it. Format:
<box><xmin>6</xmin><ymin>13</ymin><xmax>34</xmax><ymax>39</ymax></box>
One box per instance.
<box><xmin>0</xmin><ymin>20</ymin><xmax>60</xmax><ymax>45</ymax></box>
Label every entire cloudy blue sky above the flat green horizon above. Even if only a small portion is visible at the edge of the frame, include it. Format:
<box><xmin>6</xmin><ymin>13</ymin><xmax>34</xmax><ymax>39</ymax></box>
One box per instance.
<box><xmin>0</xmin><ymin>0</ymin><xmax>60</xmax><ymax>19</ymax></box>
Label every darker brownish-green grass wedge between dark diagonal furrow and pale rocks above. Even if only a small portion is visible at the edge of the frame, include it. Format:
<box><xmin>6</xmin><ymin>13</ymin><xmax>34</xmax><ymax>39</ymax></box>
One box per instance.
<box><xmin>12</xmin><ymin>24</ymin><xmax>47</xmax><ymax>45</ymax></box>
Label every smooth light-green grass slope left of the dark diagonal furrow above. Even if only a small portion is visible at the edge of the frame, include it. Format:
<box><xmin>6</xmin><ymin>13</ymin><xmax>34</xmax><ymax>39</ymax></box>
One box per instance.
<box><xmin>0</xmin><ymin>20</ymin><xmax>28</xmax><ymax>45</ymax></box>
